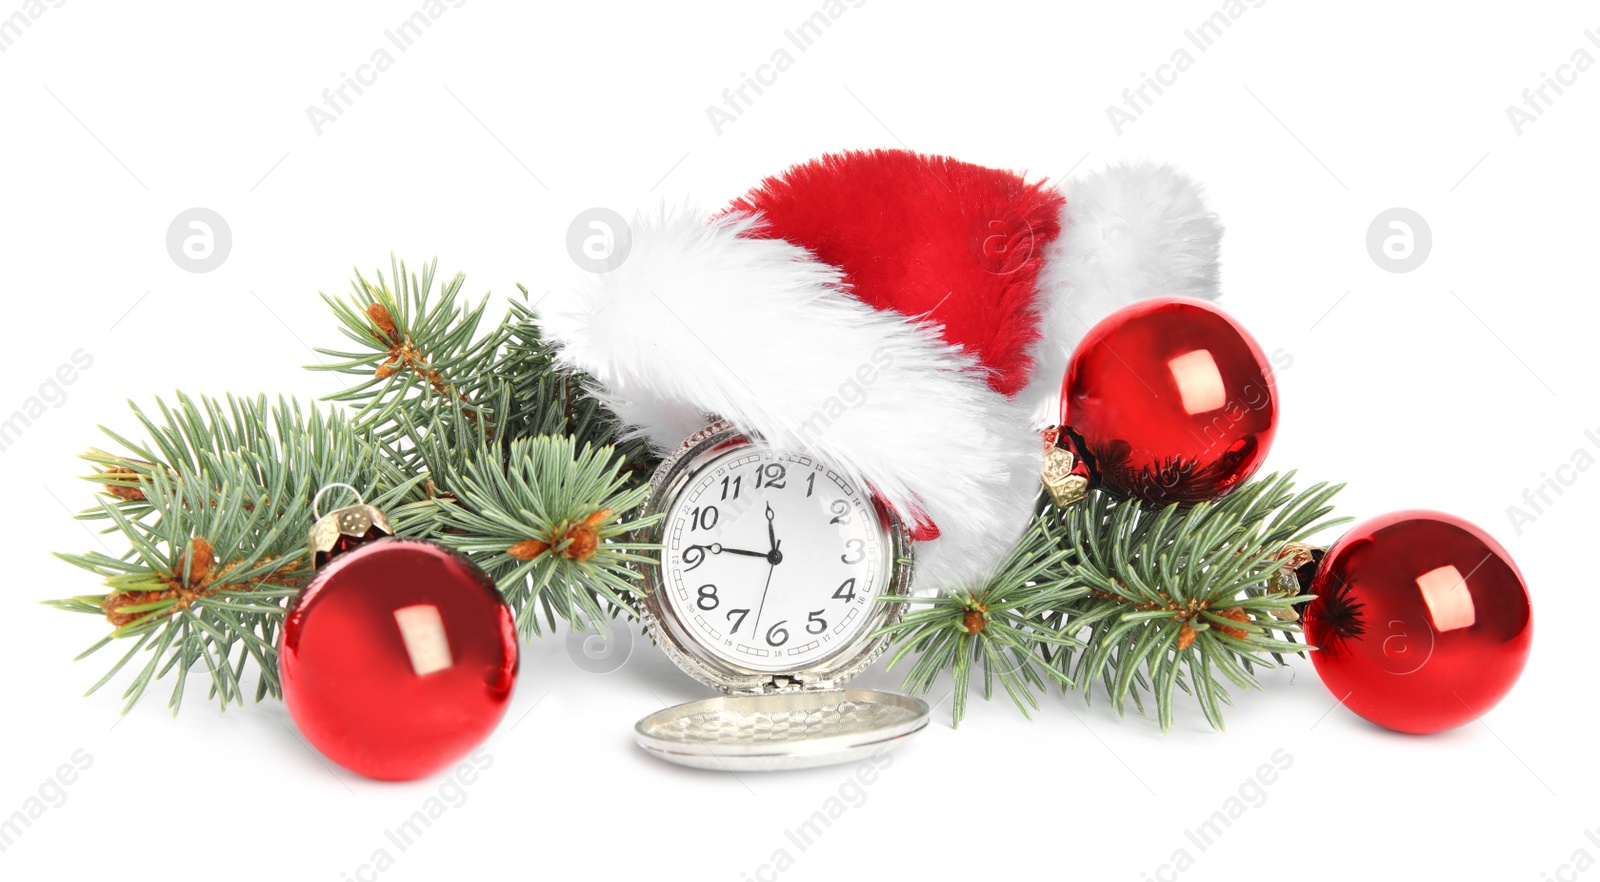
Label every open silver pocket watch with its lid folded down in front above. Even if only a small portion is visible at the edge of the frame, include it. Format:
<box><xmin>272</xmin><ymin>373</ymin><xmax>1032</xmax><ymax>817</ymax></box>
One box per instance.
<box><xmin>635</xmin><ymin>421</ymin><xmax>928</xmax><ymax>770</ymax></box>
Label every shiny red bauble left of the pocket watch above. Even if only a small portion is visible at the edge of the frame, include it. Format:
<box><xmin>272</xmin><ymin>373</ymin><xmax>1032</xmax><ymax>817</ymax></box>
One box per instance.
<box><xmin>278</xmin><ymin>536</ymin><xmax>517</xmax><ymax>781</ymax></box>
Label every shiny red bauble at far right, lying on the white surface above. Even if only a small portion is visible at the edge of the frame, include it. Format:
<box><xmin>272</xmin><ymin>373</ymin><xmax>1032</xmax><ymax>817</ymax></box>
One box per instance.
<box><xmin>1306</xmin><ymin>511</ymin><xmax>1533</xmax><ymax>735</ymax></box>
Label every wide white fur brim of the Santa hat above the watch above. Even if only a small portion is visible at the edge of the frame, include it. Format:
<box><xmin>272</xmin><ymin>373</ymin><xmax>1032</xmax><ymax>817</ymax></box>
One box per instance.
<box><xmin>539</xmin><ymin>214</ymin><xmax>1042</xmax><ymax>591</ymax></box>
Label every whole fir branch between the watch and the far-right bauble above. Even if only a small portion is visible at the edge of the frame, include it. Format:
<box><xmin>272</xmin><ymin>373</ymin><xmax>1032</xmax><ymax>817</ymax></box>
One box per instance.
<box><xmin>882</xmin><ymin>474</ymin><xmax>1344</xmax><ymax>730</ymax></box>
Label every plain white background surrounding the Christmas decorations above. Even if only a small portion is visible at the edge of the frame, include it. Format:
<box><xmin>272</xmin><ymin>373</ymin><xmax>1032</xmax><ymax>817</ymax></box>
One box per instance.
<box><xmin>0</xmin><ymin>0</ymin><xmax>1600</xmax><ymax>880</ymax></box>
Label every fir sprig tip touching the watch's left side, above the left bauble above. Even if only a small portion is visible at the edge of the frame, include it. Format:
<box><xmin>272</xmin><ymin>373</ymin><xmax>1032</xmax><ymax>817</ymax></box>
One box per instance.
<box><xmin>437</xmin><ymin>435</ymin><xmax>654</xmax><ymax>637</ymax></box>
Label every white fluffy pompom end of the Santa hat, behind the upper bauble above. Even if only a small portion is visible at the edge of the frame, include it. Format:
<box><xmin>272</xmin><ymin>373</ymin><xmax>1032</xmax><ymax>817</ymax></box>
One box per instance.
<box><xmin>1018</xmin><ymin>163</ymin><xmax>1222</xmax><ymax>426</ymax></box>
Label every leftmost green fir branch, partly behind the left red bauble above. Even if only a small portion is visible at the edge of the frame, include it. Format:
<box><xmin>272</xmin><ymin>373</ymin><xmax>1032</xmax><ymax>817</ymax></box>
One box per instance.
<box><xmin>48</xmin><ymin>395</ymin><xmax>419</xmax><ymax>712</ymax></box>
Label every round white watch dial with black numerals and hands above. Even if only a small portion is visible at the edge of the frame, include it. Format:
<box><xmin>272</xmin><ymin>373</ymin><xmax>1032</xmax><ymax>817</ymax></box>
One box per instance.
<box><xmin>662</xmin><ymin>445</ymin><xmax>890</xmax><ymax>672</ymax></box>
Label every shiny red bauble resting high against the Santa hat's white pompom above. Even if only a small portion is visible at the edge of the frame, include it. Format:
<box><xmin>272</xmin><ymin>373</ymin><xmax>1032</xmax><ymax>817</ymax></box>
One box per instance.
<box><xmin>1061</xmin><ymin>298</ymin><xmax>1278</xmax><ymax>504</ymax></box>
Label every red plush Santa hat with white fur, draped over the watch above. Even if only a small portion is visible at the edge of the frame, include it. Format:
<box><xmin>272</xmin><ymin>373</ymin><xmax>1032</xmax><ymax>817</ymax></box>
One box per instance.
<box><xmin>539</xmin><ymin>150</ymin><xmax>1221</xmax><ymax>591</ymax></box>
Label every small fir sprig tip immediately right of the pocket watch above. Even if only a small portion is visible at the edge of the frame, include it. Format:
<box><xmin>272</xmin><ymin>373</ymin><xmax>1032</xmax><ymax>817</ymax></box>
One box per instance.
<box><xmin>878</xmin><ymin>517</ymin><xmax>1085</xmax><ymax>725</ymax></box>
